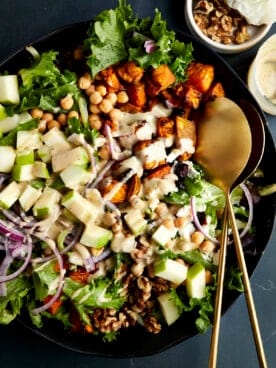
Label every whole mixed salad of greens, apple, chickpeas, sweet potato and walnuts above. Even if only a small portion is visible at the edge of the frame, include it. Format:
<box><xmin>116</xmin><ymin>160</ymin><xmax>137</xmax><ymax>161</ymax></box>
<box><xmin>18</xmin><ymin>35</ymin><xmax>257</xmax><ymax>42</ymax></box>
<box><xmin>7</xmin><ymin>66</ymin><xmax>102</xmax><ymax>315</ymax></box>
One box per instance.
<box><xmin>0</xmin><ymin>0</ymin><xmax>275</xmax><ymax>348</ymax></box>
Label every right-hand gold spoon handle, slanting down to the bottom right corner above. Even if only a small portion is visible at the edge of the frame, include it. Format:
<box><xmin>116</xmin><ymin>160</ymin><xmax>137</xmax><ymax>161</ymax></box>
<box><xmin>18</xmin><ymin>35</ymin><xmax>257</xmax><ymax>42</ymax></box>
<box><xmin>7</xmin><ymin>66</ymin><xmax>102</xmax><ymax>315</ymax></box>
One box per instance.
<box><xmin>226</xmin><ymin>196</ymin><xmax>267</xmax><ymax>368</ymax></box>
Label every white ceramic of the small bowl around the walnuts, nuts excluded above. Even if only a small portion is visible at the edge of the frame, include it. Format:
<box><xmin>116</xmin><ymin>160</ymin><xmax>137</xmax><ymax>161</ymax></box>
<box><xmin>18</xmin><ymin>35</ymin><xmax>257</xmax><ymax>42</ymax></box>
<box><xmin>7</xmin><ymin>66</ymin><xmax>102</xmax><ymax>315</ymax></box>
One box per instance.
<box><xmin>184</xmin><ymin>0</ymin><xmax>271</xmax><ymax>54</ymax></box>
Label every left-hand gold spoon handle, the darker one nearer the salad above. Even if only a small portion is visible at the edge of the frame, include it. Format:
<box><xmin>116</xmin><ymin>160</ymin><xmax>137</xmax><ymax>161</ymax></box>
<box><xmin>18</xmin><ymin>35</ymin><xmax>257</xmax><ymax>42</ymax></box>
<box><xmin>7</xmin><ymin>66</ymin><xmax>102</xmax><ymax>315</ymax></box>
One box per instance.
<box><xmin>208</xmin><ymin>207</ymin><xmax>228</xmax><ymax>368</ymax></box>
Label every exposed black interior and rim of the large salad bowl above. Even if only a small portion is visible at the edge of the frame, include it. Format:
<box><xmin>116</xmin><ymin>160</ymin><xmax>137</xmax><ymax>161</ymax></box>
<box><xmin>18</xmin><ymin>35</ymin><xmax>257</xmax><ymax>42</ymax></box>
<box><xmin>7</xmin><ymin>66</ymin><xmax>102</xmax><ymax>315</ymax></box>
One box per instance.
<box><xmin>0</xmin><ymin>22</ymin><xmax>276</xmax><ymax>358</ymax></box>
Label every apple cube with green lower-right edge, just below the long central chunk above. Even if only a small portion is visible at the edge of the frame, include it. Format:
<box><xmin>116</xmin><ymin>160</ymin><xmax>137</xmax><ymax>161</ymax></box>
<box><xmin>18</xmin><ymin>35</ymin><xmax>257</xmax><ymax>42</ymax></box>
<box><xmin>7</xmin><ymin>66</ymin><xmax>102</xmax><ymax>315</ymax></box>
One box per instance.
<box><xmin>80</xmin><ymin>224</ymin><xmax>112</xmax><ymax>248</ymax></box>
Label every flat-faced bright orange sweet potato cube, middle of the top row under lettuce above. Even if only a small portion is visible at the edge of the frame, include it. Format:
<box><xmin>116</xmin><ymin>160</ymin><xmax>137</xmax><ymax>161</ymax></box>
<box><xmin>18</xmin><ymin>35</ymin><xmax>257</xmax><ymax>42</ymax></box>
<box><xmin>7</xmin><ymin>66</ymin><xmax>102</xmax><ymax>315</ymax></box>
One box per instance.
<box><xmin>147</xmin><ymin>64</ymin><xmax>176</xmax><ymax>97</ymax></box>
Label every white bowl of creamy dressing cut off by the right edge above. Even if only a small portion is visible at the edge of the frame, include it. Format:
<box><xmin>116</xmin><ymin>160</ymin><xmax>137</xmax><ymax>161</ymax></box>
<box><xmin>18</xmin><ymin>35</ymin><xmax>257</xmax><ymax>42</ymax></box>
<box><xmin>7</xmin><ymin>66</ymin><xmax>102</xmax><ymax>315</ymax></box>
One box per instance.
<box><xmin>247</xmin><ymin>34</ymin><xmax>276</xmax><ymax>115</ymax></box>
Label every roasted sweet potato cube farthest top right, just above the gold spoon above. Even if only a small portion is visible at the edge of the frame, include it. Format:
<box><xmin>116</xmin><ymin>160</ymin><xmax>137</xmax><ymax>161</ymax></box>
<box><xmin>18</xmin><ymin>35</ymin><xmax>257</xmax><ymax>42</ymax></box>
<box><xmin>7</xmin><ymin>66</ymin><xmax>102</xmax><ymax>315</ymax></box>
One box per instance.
<box><xmin>187</xmin><ymin>62</ymin><xmax>215</xmax><ymax>93</ymax></box>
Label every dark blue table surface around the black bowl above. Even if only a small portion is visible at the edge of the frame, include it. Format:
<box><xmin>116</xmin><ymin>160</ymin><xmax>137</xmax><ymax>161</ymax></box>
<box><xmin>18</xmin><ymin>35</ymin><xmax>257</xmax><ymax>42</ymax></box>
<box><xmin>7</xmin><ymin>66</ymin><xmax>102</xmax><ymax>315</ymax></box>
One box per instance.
<box><xmin>0</xmin><ymin>0</ymin><xmax>276</xmax><ymax>368</ymax></box>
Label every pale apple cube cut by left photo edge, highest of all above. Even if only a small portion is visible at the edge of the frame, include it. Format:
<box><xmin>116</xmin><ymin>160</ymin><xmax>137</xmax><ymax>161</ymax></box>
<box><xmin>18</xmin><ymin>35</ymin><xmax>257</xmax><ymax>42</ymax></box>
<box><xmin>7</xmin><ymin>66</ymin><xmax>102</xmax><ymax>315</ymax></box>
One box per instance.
<box><xmin>0</xmin><ymin>74</ymin><xmax>20</xmax><ymax>105</ymax></box>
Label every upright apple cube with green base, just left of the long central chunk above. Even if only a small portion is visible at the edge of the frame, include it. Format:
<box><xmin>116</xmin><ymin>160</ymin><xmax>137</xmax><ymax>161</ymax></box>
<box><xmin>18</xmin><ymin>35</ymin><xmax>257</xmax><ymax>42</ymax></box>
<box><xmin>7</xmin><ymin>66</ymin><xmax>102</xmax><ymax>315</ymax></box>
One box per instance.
<box><xmin>33</xmin><ymin>187</ymin><xmax>61</xmax><ymax>218</ymax></box>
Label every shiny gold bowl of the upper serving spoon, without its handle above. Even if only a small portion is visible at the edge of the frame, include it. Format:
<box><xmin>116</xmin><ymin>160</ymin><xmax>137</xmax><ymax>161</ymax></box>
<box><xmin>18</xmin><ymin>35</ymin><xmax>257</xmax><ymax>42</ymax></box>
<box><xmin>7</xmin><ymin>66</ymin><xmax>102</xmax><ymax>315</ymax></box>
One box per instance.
<box><xmin>195</xmin><ymin>97</ymin><xmax>252</xmax><ymax>195</ymax></box>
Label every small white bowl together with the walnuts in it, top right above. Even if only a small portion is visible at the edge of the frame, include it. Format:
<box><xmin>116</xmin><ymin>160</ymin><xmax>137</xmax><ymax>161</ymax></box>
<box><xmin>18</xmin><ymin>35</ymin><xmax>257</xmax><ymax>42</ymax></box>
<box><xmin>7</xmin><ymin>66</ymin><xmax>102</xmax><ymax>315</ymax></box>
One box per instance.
<box><xmin>184</xmin><ymin>0</ymin><xmax>271</xmax><ymax>54</ymax></box>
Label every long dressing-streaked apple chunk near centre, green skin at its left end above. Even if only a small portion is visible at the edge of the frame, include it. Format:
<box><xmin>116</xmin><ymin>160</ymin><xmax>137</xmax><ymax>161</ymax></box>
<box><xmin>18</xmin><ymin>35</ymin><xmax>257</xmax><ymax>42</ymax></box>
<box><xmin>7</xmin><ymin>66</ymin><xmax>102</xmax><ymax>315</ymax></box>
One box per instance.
<box><xmin>61</xmin><ymin>190</ymin><xmax>104</xmax><ymax>224</ymax></box>
